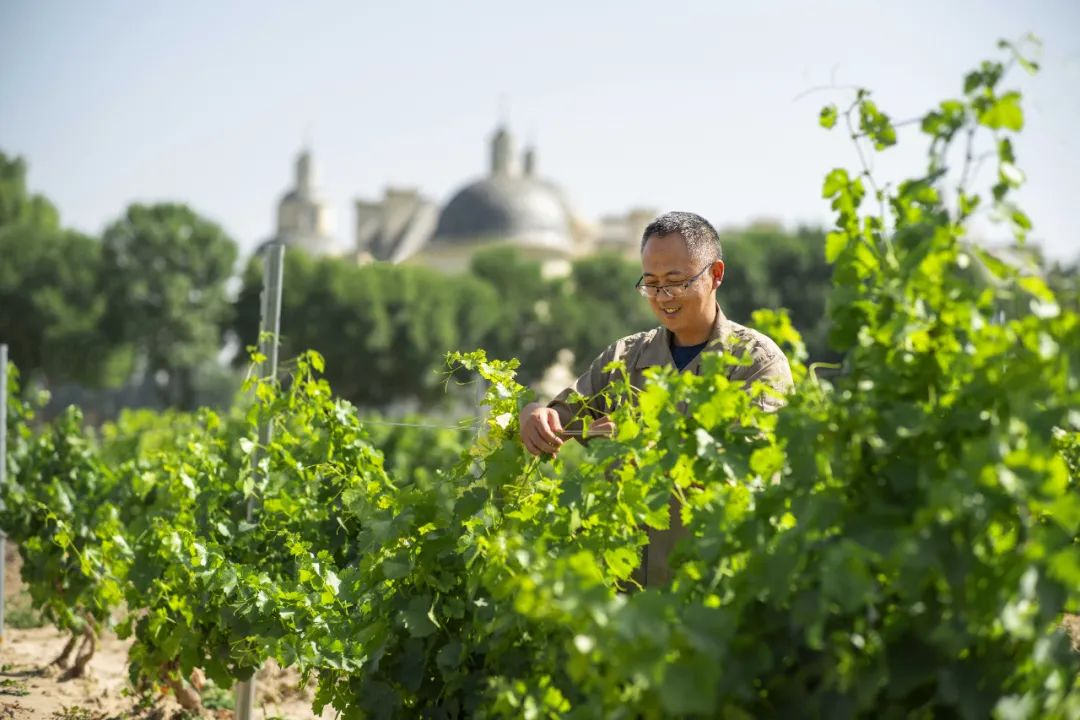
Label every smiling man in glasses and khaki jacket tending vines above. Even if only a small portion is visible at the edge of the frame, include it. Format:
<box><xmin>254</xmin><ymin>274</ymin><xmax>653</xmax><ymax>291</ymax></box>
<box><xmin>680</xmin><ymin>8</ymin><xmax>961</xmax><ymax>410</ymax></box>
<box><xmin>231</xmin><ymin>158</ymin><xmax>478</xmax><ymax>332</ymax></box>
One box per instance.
<box><xmin>521</xmin><ymin>213</ymin><xmax>793</xmax><ymax>586</ymax></box>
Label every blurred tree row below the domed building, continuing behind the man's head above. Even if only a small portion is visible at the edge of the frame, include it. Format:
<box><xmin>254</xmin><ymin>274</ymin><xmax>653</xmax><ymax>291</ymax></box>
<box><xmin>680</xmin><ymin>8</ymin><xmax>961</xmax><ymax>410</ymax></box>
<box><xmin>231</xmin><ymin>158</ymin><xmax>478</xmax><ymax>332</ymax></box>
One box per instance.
<box><xmin>232</xmin><ymin>226</ymin><xmax>832</xmax><ymax>404</ymax></box>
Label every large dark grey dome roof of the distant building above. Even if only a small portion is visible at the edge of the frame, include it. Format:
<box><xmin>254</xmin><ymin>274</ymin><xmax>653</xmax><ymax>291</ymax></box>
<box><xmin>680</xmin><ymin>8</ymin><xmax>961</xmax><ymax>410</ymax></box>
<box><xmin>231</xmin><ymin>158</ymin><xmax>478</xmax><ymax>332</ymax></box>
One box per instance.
<box><xmin>432</xmin><ymin>174</ymin><xmax>573</xmax><ymax>255</ymax></box>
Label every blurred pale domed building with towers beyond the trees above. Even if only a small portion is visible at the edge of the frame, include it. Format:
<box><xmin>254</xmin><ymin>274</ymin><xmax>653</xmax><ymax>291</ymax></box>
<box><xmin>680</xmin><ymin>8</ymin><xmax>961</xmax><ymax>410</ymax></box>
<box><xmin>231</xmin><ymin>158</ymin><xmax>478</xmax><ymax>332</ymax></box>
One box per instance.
<box><xmin>270</xmin><ymin>127</ymin><xmax>656</xmax><ymax>274</ymax></box>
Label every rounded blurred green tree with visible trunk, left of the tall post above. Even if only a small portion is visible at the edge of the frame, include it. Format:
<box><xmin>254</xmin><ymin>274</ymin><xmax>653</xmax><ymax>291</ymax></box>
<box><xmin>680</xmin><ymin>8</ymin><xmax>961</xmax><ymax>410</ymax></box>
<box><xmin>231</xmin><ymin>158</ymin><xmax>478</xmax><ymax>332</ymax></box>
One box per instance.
<box><xmin>102</xmin><ymin>203</ymin><xmax>237</xmax><ymax>408</ymax></box>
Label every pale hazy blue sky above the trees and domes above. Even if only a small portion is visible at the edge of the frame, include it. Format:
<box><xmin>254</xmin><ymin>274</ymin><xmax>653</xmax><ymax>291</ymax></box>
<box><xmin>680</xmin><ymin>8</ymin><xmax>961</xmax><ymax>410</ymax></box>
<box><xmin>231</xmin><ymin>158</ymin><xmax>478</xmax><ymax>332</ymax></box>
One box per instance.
<box><xmin>0</xmin><ymin>0</ymin><xmax>1080</xmax><ymax>259</ymax></box>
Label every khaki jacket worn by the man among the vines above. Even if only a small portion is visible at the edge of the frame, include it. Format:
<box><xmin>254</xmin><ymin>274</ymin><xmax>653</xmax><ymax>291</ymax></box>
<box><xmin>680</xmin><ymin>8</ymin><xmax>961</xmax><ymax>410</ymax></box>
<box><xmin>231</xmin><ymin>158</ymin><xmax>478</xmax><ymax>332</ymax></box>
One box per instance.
<box><xmin>548</xmin><ymin>305</ymin><xmax>793</xmax><ymax>587</ymax></box>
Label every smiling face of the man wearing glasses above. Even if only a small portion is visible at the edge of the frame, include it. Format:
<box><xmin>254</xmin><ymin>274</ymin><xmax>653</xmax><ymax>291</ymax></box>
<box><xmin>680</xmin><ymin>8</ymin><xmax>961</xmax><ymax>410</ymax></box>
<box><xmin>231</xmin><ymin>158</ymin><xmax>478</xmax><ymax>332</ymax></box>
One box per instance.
<box><xmin>642</xmin><ymin>233</ymin><xmax>724</xmax><ymax>336</ymax></box>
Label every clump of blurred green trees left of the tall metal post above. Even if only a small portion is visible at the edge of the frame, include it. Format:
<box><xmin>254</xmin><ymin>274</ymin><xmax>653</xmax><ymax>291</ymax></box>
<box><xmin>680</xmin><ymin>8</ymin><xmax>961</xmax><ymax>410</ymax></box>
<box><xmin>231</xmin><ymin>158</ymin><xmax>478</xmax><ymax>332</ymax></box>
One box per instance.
<box><xmin>0</xmin><ymin>153</ymin><xmax>237</xmax><ymax>407</ymax></box>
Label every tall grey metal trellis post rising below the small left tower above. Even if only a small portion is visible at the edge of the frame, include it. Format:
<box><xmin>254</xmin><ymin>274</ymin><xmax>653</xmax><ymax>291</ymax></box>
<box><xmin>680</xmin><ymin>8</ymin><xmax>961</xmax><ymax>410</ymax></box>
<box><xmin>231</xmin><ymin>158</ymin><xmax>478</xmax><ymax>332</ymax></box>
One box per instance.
<box><xmin>234</xmin><ymin>241</ymin><xmax>285</xmax><ymax>720</ymax></box>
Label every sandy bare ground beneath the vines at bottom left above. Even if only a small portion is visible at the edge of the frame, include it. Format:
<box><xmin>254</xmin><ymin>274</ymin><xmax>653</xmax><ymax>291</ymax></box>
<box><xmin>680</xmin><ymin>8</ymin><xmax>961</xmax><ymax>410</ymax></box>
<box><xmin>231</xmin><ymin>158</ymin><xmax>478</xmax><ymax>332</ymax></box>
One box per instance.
<box><xmin>0</xmin><ymin>543</ymin><xmax>334</xmax><ymax>720</ymax></box>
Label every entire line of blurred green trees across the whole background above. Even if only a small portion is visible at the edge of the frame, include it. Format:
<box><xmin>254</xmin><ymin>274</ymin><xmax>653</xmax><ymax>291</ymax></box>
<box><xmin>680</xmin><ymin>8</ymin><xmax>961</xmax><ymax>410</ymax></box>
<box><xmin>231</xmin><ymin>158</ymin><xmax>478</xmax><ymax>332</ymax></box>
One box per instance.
<box><xmin>0</xmin><ymin>147</ymin><xmax>1078</xmax><ymax>409</ymax></box>
